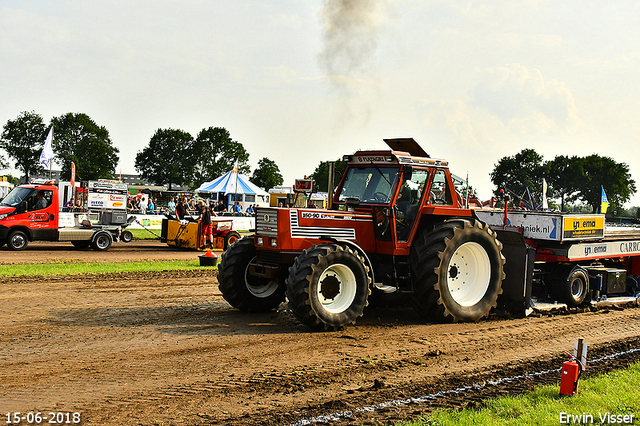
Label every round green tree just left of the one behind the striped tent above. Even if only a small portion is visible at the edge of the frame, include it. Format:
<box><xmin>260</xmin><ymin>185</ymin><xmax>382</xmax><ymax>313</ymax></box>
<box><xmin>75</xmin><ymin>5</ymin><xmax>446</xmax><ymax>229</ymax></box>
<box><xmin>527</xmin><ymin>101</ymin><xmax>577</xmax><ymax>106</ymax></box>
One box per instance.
<box><xmin>135</xmin><ymin>129</ymin><xmax>193</xmax><ymax>190</ymax></box>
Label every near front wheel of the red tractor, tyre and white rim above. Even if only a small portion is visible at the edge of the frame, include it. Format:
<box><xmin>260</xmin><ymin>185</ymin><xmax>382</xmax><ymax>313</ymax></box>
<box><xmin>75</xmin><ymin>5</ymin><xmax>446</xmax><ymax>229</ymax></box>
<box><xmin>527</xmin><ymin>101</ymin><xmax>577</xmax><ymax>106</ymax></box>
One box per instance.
<box><xmin>287</xmin><ymin>244</ymin><xmax>371</xmax><ymax>330</ymax></box>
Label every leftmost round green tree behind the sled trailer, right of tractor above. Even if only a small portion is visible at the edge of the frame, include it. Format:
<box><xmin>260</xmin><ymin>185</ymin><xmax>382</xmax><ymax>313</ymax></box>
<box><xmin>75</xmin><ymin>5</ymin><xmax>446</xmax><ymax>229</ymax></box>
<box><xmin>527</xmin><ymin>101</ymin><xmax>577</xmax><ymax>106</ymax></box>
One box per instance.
<box><xmin>490</xmin><ymin>148</ymin><xmax>547</xmax><ymax>207</ymax></box>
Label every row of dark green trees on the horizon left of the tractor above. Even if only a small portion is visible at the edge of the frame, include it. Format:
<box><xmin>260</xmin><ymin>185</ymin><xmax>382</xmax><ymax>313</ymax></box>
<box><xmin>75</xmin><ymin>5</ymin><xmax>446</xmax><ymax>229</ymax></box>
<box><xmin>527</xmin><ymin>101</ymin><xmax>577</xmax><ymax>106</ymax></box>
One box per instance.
<box><xmin>0</xmin><ymin>111</ymin><xmax>284</xmax><ymax>189</ymax></box>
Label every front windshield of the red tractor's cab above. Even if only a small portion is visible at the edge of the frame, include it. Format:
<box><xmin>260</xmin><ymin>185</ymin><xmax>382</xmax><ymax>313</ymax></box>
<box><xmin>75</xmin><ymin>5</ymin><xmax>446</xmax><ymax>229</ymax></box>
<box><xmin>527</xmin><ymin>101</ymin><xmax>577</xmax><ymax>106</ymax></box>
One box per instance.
<box><xmin>338</xmin><ymin>166</ymin><xmax>398</xmax><ymax>204</ymax></box>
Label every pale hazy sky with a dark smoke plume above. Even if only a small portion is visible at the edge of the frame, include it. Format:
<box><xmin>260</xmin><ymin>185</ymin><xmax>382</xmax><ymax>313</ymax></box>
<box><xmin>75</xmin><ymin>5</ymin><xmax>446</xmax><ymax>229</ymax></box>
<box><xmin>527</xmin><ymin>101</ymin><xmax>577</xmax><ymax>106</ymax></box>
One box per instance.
<box><xmin>0</xmin><ymin>0</ymin><xmax>640</xmax><ymax>207</ymax></box>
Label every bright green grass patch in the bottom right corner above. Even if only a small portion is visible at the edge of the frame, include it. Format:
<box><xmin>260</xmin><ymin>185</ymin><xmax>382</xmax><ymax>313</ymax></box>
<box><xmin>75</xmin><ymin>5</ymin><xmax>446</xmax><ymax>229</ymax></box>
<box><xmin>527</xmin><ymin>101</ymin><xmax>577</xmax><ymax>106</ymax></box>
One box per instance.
<box><xmin>396</xmin><ymin>363</ymin><xmax>640</xmax><ymax>426</ymax></box>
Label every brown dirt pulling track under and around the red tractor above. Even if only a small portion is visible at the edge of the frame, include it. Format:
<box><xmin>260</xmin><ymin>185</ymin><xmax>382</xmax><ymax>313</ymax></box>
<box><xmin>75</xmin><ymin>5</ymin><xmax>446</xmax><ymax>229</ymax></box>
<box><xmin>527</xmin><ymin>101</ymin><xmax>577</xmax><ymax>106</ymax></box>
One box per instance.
<box><xmin>0</xmin><ymin>242</ymin><xmax>640</xmax><ymax>425</ymax></box>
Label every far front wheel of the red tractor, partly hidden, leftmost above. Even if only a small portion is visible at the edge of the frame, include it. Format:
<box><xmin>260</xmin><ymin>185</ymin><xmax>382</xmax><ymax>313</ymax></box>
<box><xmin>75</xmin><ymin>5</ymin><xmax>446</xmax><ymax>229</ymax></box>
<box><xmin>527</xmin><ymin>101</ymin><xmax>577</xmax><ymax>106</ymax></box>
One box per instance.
<box><xmin>218</xmin><ymin>238</ymin><xmax>284</xmax><ymax>312</ymax></box>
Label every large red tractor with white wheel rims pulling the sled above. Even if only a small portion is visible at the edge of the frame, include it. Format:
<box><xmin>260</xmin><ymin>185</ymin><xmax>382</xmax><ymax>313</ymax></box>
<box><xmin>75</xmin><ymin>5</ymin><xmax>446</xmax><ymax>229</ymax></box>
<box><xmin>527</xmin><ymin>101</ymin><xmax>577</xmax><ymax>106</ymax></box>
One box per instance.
<box><xmin>218</xmin><ymin>139</ymin><xmax>512</xmax><ymax>329</ymax></box>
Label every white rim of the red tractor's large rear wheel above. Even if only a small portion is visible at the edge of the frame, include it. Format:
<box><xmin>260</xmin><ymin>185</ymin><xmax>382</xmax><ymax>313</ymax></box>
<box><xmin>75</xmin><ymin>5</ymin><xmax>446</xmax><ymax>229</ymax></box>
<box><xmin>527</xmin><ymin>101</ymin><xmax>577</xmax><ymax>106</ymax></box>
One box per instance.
<box><xmin>446</xmin><ymin>242</ymin><xmax>491</xmax><ymax>306</ymax></box>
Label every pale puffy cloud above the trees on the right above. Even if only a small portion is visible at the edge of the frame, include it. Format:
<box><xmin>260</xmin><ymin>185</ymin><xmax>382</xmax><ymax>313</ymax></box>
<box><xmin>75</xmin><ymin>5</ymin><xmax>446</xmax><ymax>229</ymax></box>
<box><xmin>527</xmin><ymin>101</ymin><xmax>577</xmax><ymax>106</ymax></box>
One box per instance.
<box><xmin>469</xmin><ymin>64</ymin><xmax>580</xmax><ymax>134</ymax></box>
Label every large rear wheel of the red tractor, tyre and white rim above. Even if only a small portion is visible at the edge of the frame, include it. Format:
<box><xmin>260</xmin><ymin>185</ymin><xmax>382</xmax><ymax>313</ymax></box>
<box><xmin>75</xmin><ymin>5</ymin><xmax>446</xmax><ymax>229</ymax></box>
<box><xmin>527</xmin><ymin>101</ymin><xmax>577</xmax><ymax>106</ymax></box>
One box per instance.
<box><xmin>410</xmin><ymin>219</ymin><xmax>505</xmax><ymax>322</ymax></box>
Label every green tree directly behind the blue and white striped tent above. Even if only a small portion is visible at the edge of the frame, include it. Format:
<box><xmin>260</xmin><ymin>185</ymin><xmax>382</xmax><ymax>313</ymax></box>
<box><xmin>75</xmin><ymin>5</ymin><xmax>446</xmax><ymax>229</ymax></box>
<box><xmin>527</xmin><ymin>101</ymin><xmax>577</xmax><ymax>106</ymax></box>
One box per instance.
<box><xmin>190</xmin><ymin>127</ymin><xmax>250</xmax><ymax>188</ymax></box>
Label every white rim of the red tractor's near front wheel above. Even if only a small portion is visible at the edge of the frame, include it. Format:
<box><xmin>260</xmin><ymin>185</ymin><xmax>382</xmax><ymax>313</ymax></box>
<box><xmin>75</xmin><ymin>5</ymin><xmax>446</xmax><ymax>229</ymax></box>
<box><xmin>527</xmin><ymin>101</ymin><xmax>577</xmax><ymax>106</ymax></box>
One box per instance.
<box><xmin>316</xmin><ymin>264</ymin><xmax>358</xmax><ymax>314</ymax></box>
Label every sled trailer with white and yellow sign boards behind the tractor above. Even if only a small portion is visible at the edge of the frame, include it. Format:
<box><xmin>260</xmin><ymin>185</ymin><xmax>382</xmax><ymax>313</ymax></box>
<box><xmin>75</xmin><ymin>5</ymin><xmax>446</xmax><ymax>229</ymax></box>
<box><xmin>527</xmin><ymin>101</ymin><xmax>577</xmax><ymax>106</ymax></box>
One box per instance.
<box><xmin>475</xmin><ymin>209</ymin><xmax>640</xmax><ymax>312</ymax></box>
